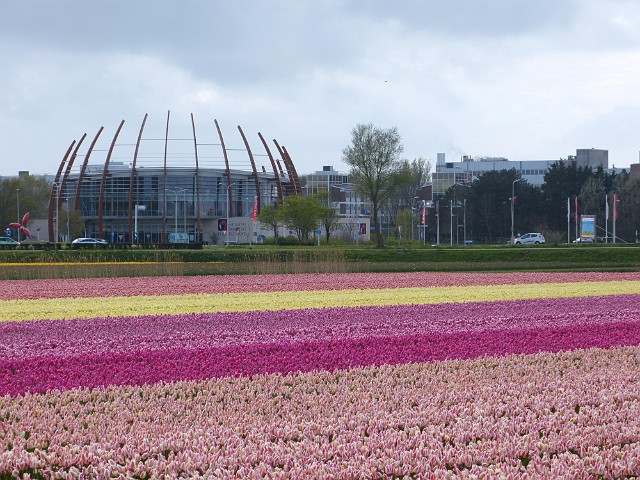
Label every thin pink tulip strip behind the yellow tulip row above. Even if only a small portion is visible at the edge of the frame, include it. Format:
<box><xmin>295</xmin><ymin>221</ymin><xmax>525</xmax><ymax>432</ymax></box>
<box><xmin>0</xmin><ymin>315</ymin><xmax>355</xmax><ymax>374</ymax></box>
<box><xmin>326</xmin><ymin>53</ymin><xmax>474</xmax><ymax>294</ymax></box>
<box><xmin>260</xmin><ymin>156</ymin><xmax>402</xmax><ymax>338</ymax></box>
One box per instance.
<box><xmin>0</xmin><ymin>272</ymin><xmax>640</xmax><ymax>300</ymax></box>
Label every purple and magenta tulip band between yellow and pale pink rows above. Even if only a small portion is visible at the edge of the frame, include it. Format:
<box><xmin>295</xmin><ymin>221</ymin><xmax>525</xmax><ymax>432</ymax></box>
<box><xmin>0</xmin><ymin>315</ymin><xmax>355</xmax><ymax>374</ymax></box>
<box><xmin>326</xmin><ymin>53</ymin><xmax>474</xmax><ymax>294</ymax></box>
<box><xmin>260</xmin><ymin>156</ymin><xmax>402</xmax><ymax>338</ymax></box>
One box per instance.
<box><xmin>0</xmin><ymin>295</ymin><xmax>640</xmax><ymax>395</ymax></box>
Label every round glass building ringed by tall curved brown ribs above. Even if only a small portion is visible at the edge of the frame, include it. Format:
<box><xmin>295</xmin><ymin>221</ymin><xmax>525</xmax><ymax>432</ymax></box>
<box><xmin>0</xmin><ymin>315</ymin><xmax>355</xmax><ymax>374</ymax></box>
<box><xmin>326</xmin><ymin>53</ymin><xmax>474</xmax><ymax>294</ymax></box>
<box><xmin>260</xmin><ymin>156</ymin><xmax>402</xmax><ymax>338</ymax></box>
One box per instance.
<box><xmin>48</xmin><ymin>112</ymin><xmax>301</xmax><ymax>244</ymax></box>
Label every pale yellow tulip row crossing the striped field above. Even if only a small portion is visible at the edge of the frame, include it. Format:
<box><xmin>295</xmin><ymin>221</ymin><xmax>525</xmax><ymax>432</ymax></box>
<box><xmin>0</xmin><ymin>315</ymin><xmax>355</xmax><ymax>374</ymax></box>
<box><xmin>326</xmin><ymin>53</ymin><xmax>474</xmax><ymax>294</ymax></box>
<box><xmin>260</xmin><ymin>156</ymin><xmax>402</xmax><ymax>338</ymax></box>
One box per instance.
<box><xmin>0</xmin><ymin>280</ymin><xmax>640</xmax><ymax>322</ymax></box>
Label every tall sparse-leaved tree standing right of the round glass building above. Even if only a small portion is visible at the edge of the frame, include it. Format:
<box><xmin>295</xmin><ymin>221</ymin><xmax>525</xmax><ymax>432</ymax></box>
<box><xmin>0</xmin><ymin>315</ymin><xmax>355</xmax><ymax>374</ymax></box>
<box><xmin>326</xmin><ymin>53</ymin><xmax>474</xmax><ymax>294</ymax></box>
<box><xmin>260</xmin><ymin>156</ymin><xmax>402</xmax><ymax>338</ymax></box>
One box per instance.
<box><xmin>342</xmin><ymin>124</ymin><xmax>403</xmax><ymax>247</ymax></box>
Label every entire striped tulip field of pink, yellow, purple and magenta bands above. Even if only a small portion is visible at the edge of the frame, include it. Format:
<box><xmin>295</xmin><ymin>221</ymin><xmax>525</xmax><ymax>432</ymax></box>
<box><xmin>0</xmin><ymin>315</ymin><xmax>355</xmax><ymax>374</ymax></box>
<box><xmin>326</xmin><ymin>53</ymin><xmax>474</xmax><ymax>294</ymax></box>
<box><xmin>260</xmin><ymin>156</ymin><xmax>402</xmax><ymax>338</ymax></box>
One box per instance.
<box><xmin>0</xmin><ymin>272</ymin><xmax>640</xmax><ymax>479</ymax></box>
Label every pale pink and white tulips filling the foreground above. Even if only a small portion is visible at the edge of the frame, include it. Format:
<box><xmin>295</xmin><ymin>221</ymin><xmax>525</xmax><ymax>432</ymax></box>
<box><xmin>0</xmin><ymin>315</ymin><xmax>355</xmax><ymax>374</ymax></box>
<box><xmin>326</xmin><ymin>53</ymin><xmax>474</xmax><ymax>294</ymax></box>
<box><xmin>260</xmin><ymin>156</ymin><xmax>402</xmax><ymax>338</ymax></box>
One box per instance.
<box><xmin>0</xmin><ymin>347</ymin><xmax>640</xmax><ymax>479</ymax></box>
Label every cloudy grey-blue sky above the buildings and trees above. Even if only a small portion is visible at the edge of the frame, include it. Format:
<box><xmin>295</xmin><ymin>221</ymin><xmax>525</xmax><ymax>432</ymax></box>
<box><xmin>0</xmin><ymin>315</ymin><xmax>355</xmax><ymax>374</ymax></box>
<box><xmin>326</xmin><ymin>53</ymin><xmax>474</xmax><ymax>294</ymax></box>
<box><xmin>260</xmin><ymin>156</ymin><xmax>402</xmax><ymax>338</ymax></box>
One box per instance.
<box><xmin>0</xmin><ymin>0</ymin><xmax>640</xmax><ymax>175</ymax></box>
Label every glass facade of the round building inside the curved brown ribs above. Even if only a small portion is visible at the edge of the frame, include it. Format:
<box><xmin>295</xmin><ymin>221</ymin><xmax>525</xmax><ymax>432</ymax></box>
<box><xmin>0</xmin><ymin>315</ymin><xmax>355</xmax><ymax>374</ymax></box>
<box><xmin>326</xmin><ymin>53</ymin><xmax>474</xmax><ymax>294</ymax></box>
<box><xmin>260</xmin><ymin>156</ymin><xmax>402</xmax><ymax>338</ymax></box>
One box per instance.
<box><xmin>63</xmin><ymin>169</ymin><xmax>278</xmax><ymax>243</ymax></box>
